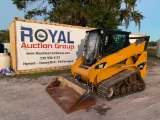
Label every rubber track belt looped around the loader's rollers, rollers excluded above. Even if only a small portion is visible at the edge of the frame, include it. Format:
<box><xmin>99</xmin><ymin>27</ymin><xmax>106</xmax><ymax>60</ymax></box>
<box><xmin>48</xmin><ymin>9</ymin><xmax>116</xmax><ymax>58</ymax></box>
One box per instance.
<box><xmin>97</xmin><ymin>70</ymin><xmax>145</xmax><ymax>100</ymax></box>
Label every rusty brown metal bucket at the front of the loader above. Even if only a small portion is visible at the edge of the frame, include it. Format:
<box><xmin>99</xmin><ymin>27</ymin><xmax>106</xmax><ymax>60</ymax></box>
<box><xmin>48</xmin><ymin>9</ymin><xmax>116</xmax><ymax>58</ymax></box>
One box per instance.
<box><xmin>46</xmin><ymin>75</ymin><xmax>96</xmax><ymax>113</ymax></box>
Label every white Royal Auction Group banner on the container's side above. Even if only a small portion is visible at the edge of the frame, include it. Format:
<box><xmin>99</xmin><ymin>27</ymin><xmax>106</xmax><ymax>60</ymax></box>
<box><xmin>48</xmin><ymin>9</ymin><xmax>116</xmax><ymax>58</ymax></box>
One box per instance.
<box><xmin>15</xmin><ymin>21</ymin><xmax>86</xmax><ymax>70</ymax></box>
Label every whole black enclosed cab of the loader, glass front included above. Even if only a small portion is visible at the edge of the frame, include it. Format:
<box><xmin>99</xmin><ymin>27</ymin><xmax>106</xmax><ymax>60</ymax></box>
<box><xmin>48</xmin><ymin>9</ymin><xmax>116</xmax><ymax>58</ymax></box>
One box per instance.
<box><xmin>83</xmin><ymin>29</ymin><xmax>130</xmax><ymax>66</ymax></box>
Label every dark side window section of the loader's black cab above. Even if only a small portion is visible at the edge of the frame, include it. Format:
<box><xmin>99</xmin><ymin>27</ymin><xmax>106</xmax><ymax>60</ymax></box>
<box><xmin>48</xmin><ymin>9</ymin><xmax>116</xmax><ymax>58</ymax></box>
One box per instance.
<box><xmin>100</xmin><ymin>30</ymin><xmax>130</xmax><ymax>58</ymax></box>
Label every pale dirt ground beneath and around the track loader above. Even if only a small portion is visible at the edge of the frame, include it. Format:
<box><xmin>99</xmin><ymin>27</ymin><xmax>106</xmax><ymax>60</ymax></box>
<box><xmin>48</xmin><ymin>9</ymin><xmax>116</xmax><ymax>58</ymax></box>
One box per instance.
<box><xmin>0</xmin><ymin>59</ymin><xmax>160</xmax><ymax>120</ymax></box>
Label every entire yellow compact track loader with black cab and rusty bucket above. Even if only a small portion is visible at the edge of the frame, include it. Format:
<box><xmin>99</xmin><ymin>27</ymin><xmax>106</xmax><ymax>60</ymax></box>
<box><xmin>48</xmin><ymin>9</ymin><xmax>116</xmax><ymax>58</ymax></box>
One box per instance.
<box><xmin>46</xmin><ymin>29</ymin><xmax>149</xmax><ymax>113</ymax></box>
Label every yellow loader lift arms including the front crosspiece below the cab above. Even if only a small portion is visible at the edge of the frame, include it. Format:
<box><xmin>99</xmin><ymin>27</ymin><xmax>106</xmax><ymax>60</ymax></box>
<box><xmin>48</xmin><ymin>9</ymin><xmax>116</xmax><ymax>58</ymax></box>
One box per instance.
<box><xmin>71</xmin><ymin>41</ymin><xmax>147</xmax><ymax>86</ymax></box>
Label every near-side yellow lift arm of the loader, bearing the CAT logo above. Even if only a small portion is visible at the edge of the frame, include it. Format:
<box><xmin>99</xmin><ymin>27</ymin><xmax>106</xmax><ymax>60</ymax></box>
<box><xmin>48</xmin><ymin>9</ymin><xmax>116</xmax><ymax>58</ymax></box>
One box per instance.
<box><xmin>89</xmin><ymin>41</ymin><xmax>147</xmax><ymax>83</ymax></box>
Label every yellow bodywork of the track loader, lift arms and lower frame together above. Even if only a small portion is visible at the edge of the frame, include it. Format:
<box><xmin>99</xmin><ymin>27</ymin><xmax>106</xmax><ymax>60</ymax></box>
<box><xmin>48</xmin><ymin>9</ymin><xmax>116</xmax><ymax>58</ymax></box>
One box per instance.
<box><xmin>71</xmin><ymin>41</ymin><xmax>147</xmax><ymax>87</ymax></box>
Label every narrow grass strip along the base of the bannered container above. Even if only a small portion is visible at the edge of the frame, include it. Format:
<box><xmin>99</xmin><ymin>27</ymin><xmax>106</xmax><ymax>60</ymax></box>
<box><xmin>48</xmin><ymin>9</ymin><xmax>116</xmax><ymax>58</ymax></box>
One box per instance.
<box><xmin>3</xmin><ymin>69</ymin><xmax>71</xmax><ymax>79</ymax></box>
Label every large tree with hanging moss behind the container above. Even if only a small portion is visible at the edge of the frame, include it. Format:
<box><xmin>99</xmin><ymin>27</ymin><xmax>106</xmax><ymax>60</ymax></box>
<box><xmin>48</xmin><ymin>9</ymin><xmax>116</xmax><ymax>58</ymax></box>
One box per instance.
<box><xmin>12</xmin><ymin>0</ymin><xmax>144</xmax><ymax>29</ymax></box>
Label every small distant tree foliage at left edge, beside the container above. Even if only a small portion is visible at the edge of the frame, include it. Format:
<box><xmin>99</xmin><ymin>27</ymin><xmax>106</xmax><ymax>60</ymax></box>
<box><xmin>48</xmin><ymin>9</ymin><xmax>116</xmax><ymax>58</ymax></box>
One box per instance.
<box><xmin>0</xmin><ymin>30</ymin><xmax>9</xmax><ymax>43</ymax></box>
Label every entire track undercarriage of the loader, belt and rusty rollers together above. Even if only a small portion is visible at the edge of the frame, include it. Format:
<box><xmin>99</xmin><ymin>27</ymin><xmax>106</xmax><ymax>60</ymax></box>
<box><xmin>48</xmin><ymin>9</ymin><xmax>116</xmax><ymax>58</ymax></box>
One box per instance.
<box><xmin>97</xmin><ymin>70</ymin><xmax>145</xmax><ymax>100</ymax></box>
